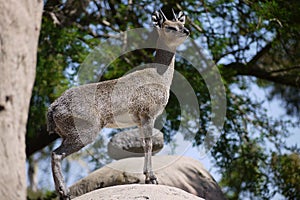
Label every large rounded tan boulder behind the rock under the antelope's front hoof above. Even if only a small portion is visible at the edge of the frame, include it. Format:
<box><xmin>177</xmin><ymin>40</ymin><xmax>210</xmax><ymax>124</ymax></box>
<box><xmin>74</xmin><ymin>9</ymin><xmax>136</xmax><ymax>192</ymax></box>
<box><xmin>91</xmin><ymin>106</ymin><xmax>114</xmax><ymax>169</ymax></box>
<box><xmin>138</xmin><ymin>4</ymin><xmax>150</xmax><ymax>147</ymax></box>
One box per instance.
<box><xmin>70</xmin><ymin>156</ymin><xmax>225</xmax><ymax>200</ymax></box>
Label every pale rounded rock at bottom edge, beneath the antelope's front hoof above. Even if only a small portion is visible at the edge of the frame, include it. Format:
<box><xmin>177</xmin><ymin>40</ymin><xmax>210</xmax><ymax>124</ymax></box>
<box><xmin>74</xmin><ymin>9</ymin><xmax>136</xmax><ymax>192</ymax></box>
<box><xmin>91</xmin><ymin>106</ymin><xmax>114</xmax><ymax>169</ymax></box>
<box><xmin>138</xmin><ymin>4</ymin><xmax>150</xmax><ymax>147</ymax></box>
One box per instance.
<box><xmin>74</xmin><ymin>184</ymin><xmax>204</xmax><ymax>200</ymax></box>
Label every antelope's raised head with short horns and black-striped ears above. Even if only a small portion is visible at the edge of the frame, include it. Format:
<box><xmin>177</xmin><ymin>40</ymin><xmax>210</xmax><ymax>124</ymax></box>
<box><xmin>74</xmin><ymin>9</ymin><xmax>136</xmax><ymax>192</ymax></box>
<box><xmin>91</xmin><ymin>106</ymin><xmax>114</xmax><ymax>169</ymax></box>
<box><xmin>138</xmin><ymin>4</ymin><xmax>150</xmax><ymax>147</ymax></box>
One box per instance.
<box><xmin>152</xmin><ymin>9</ymin><xmax>190</xmax><ymax>48</ymax></box>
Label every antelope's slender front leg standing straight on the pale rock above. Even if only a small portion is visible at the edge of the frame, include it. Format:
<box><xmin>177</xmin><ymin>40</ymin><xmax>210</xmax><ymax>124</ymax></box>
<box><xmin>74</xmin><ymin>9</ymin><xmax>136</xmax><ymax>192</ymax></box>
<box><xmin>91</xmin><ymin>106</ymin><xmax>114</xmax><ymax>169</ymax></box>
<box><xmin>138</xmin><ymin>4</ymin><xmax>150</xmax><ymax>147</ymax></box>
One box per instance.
<box><xmin>140</xmin><ymin>117</ymin><xmax>158</xmax><ymax>184</ymax></box>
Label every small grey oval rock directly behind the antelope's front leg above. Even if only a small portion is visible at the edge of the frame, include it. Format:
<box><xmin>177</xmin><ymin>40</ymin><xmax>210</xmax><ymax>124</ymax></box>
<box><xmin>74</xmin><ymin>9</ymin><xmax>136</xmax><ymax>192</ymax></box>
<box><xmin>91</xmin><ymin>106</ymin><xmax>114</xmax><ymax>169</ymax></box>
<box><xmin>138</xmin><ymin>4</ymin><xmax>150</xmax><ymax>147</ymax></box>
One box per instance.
<box><xmin>107</xmin><ymin>128</ymin><xmax>164</xmax><ymax>160</ymax></box>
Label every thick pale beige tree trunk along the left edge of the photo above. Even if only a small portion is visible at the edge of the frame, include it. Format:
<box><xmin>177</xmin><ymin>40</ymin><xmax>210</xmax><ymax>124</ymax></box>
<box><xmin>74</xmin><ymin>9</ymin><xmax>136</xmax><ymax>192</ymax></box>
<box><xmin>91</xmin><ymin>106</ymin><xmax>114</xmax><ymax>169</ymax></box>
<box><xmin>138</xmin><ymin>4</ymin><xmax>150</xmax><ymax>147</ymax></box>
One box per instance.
<box><xmin>0</xmin><ymin>0</ymin><xmax>43</xmax><ymax>200</ymax></box>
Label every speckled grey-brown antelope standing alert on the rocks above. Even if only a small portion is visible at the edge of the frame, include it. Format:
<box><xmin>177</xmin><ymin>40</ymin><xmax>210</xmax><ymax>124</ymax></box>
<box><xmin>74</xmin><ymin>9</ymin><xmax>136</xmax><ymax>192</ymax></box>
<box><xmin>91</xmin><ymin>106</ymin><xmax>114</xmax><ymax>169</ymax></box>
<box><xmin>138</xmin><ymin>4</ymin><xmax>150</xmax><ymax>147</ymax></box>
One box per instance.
<box><xmin>47</xmin><ymin>10</ymin><xmax>189</xmax><ymax>200</ymax></box>
